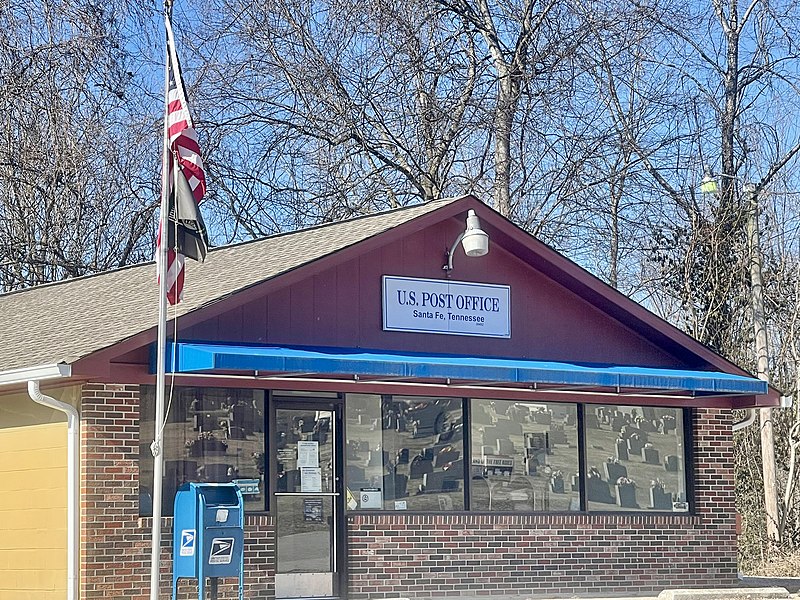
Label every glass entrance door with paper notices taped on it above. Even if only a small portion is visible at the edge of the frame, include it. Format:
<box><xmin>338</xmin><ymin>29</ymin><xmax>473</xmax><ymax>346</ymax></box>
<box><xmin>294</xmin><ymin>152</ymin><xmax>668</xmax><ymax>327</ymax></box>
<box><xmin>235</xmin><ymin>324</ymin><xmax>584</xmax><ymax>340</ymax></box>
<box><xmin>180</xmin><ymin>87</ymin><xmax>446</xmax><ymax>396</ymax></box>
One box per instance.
<box><xmin>272</xmin><ymin>400</ymin><xmax>344</xmax><ymax>598</ymax></box>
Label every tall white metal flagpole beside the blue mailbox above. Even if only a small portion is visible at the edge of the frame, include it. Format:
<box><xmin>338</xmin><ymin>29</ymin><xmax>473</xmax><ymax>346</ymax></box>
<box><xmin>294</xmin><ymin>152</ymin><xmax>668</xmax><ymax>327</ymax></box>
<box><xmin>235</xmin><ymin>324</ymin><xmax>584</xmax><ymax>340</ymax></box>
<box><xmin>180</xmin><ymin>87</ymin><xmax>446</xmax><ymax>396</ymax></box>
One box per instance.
<box><xmin>150</xmin><ymin>0</ymin><xmax>172</xmax><ymax>600</ymax></box>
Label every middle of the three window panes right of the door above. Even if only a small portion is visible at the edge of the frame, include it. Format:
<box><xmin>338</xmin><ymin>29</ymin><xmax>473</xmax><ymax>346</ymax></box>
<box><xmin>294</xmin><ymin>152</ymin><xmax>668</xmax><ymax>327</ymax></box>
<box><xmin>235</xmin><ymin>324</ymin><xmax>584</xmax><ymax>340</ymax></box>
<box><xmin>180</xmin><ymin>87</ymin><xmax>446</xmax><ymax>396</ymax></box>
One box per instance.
<box><xmin>470</xmin><ymin>399</ymin><xmax>580</xmax><ymax>512</ymax></box>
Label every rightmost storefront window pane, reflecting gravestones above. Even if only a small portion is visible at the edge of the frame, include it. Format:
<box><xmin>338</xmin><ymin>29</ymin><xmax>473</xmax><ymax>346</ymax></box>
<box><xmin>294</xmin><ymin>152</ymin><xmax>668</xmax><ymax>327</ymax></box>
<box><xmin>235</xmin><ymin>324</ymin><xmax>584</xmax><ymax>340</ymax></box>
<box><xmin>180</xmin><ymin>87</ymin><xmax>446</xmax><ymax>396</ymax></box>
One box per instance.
<box><xmin>584</xmin><ymin>405</ymin><xmax>688</xmax><ymax>511</ymax></box>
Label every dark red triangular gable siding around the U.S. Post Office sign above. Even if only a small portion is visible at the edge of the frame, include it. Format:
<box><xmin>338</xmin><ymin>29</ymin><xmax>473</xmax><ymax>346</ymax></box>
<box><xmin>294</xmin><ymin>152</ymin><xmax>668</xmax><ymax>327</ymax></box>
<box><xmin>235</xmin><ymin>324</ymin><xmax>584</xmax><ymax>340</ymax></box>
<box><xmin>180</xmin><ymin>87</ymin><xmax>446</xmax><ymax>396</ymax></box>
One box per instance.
<box><xmin>182</xmin><ymin>212</ymin><xmax>685</xmax><ymax>367</ymax></box>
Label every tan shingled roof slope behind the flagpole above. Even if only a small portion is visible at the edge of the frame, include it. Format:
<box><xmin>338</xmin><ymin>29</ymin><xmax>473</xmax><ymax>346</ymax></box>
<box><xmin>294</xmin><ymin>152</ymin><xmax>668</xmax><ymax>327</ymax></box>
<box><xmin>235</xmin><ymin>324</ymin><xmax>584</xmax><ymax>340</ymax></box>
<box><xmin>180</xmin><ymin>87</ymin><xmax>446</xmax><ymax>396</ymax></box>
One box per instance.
<box><xmin>0</xmin><ymin>199</ymin><xmax>454</xmax><ymax>372</ymax></box>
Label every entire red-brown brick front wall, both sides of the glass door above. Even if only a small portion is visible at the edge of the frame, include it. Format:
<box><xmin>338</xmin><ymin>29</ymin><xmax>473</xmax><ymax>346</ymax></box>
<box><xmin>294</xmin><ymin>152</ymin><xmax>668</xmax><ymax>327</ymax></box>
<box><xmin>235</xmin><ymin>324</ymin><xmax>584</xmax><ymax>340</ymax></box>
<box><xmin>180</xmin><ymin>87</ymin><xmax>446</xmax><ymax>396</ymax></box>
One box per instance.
<box><xmin>81</xmin><ymin>385</ymin><xmax>736</xmax><ymax>600</ymax></box>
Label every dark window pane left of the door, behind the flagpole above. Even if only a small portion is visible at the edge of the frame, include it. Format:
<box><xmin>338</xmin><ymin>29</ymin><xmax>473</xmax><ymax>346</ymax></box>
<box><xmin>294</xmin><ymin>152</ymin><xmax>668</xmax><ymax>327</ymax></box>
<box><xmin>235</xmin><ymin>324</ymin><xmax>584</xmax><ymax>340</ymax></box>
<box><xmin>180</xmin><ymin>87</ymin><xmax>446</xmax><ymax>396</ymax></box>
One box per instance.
<box><xmin>139</xmin><ymin>386</ymin><xmax>266</xmax><ymax>515</ymax></box>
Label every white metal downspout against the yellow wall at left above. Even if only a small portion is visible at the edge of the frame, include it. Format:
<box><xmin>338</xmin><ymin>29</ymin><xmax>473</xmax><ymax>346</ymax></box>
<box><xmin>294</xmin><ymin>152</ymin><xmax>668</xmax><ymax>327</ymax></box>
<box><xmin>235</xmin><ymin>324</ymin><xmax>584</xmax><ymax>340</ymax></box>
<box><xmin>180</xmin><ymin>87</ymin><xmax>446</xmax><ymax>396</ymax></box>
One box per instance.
<box><xmin>28</xmin><ymin>380</ymin><xmax>80</xmax><ymax>600</ymax></box>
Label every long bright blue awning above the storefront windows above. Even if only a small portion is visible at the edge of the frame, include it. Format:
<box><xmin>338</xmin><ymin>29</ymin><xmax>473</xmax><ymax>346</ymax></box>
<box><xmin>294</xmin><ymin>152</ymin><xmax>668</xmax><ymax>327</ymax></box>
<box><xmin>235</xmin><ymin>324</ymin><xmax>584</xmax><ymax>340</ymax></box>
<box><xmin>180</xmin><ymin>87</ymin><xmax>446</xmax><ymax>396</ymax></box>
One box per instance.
<box><xmin>159</xmin><ymin>342</ymin><xmax>768</xmax><ymax>405</ymax></box>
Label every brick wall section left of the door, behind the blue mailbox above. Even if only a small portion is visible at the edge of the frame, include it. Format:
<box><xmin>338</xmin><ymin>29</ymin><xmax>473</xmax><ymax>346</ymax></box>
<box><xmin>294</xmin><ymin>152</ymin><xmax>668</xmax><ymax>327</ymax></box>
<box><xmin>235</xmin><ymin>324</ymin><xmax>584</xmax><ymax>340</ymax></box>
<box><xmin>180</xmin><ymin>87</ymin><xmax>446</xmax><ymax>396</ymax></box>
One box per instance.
<box><xmin>81</xmin><ymin>384</ymin><xmax>275</xmax><ymax>600</ymax></box>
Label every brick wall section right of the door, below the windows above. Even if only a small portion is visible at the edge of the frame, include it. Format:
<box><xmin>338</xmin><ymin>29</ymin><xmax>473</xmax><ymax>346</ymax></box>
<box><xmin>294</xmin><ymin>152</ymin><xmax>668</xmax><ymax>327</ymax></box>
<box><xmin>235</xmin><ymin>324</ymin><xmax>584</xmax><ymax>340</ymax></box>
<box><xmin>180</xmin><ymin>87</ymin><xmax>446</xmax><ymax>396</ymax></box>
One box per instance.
<box><xmin>348</xmin><ymin>410</ymin><xmax>737</xmax><ymax>599</ymax></box>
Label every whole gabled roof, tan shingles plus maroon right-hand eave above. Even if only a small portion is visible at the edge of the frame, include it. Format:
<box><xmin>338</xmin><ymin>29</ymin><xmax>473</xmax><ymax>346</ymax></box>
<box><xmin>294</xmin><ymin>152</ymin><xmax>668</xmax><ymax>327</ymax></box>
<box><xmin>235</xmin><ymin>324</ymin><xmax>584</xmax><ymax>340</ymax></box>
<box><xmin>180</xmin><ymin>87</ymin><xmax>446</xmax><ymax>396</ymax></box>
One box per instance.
<box><xmin>0</xmin><ymin>195</ymin><xmax>779</xmax><ymax>405</ymax></box>
